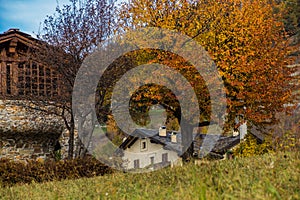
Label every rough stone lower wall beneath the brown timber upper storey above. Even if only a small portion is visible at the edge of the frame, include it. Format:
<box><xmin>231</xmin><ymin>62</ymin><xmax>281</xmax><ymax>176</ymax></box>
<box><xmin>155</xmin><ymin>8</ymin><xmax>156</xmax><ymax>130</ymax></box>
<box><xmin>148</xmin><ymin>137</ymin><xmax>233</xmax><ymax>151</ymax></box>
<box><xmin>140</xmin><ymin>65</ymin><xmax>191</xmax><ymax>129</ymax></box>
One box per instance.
<box><xmin>0</xmin><ymin>100</ymin><xmax>68</xmax><ymax>160</ymax></box>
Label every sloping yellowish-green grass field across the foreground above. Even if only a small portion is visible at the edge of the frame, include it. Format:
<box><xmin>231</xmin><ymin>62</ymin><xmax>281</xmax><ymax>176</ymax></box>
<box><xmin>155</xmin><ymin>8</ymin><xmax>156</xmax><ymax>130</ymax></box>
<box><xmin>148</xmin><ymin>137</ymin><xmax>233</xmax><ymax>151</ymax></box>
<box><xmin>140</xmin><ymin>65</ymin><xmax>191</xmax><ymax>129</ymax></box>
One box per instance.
<box><xmin>0</xmin><ymin>152</ymin><xmax>300</xmax><ymax>200</ymax></box>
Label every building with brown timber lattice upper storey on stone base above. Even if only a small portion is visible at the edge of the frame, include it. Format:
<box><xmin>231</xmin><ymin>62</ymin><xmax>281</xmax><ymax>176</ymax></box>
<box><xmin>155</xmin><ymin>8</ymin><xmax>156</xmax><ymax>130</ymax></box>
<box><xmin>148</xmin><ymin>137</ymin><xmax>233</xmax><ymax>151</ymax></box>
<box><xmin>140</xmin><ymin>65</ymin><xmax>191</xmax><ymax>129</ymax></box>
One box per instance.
<box><xmin>0</xmin><ymin>29</ymin><xmax>67</xmax><ymax>159</ymax></box>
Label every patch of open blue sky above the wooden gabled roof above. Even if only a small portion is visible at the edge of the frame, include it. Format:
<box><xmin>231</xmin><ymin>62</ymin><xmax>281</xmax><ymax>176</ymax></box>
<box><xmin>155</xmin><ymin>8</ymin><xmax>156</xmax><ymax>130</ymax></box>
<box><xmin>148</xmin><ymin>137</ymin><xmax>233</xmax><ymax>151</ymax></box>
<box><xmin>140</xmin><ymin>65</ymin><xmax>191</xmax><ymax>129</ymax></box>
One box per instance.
<box><xmin>0</xmin><ymin>0</ymin><xmax>69</xmax><ymax>35</ymax></box>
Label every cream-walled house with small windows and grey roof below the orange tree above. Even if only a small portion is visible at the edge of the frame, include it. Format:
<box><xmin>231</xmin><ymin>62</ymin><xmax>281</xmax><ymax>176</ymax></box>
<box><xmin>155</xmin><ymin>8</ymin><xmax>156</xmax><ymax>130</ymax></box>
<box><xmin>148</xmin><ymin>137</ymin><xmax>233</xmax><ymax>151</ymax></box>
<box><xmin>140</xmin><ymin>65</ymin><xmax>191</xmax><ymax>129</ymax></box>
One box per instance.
<box><xmin>118</xmin><ymin>129</ymin><xmax>181</xmax><ymax>170</ymax></box>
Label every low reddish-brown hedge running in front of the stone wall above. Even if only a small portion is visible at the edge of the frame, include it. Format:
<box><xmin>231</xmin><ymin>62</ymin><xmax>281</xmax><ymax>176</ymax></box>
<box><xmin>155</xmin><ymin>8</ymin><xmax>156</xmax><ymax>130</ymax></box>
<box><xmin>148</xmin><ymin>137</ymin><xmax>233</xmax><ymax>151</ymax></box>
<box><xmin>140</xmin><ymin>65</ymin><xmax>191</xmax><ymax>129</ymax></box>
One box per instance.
<box><xmin>0</xmin><ymin>157</ymin><xmax>113</xmax><ymax>186</ymax></box>
